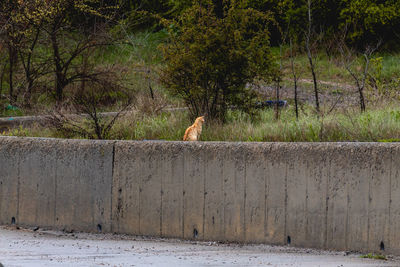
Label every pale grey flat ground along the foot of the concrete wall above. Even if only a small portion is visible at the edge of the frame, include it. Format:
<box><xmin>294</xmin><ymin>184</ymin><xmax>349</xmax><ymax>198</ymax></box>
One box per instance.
<box><xmin>0</xmin><ymin>227</ymin><xmax>400</xmax><ymax>267</ymax></box>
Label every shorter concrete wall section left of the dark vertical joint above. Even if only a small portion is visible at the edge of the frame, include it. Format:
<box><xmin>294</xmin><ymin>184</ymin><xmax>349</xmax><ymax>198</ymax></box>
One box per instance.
<box><xmin>0</xmin><ymin>137</ymin><xmax>113</xmax><ymax>234</ymax></box>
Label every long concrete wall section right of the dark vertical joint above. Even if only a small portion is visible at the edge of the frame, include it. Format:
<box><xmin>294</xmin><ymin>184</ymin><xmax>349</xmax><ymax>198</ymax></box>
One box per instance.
<box><xmin>114</xmin><ymin>142</ymin><xmax>398</xmax><ymax>253</ymax></box>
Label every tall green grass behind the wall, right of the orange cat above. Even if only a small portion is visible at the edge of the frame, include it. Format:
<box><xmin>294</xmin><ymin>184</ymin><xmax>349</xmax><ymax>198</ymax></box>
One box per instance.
<box><xmin>198</xmin><ymin>109</ymin><xmax>400</xmax><ymax>142</ymax></box>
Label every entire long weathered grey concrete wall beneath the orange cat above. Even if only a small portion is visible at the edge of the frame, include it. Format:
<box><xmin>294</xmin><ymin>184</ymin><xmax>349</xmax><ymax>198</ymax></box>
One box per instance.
<box><xmin>0</xmin><ymin>137</ymin><xmax>400</xmax><ymax>255</ymax></box>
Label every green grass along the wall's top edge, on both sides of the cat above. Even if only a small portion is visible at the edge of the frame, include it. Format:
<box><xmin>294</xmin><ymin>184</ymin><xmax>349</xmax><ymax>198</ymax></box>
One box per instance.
<box><xmin>3</xmin><ymin>104</ymin><xmax>400</xmax><ymax>142</ymax></box>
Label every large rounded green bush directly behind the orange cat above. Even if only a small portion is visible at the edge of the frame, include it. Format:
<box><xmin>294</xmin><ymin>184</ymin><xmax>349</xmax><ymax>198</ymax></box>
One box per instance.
<box><xmin>162</xmin><ymin>1</ymin><xmax>274</xmax><ymax>120</ymax></box>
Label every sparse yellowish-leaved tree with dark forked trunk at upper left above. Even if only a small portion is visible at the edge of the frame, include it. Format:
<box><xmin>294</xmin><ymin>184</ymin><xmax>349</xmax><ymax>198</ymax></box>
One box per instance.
<box><xmin>19</xmin><ymin>0</ymin><xmax>119</xmax><ymax>104</ymax></box>
